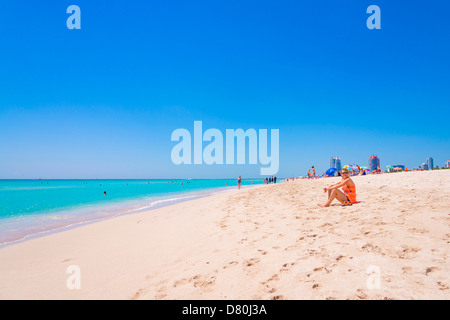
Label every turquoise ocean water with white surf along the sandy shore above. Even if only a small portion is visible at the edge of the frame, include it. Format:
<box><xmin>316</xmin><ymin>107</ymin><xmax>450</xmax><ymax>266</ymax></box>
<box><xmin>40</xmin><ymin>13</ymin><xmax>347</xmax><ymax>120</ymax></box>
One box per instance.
<box><xmin>0</xmin><ymin>179</ymin><xmax>262</xmax><ymax>246</ymax></box>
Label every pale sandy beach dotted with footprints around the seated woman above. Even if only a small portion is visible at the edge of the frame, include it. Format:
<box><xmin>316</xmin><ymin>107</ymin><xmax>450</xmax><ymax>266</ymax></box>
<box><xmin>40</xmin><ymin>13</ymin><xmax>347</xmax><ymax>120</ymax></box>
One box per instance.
<box><xmin>0</xmin><ymin>170</ymin><xmax>450</xmax><ymax>299</ymax></box>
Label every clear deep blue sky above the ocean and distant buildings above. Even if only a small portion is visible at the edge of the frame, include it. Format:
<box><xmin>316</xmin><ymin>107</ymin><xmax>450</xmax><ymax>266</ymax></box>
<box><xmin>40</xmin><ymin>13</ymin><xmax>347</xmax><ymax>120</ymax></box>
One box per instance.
<box><xmin>0</xmin><ymin>0</ymin><xmax>450</xmax><ymax>178</ymax></box>
